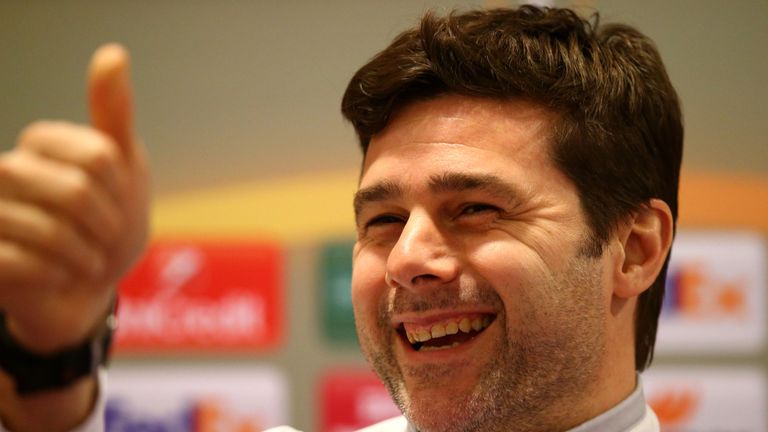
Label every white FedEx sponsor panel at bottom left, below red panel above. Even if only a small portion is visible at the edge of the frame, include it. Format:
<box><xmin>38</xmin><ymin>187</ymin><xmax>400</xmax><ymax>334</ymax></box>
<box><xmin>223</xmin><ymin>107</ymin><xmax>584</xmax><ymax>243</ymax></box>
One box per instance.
<box><xmin>105</xmin><ymin>366</ymin><xmax>289</xmax><ymax>432</ymax></box>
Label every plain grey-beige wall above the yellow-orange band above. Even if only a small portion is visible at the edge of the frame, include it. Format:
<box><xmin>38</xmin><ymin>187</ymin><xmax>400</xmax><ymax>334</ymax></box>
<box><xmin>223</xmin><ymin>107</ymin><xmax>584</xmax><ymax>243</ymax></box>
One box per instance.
<box><xmin>0</xmin><ymin>0</ymin><xmax>768</xmax><ymax>193</ymax></box>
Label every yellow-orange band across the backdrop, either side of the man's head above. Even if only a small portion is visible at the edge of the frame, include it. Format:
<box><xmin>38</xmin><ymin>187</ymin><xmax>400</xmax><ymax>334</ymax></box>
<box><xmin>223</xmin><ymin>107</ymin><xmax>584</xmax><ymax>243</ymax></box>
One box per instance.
<box><xmin>153</xmin><ymin>170</ymin><xmax>768</xmax><ymax>244</ymax></box>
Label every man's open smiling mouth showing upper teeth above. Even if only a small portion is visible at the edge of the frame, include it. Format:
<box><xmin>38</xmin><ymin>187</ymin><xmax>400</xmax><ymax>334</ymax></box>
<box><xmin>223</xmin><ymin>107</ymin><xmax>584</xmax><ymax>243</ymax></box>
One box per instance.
<box><xmin>397</xmin><ymin>315</ymin><xmax>496</xmax><ymax>351</ymax></box>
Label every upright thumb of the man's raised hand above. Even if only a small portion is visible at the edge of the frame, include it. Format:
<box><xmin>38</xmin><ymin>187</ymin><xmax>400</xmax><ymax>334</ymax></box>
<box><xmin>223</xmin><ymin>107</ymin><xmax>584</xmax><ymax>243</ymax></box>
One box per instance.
<box><xmin>88</xmin><ymin>43</ymin><xmax>135</xmax><ymax>158</ymax></box>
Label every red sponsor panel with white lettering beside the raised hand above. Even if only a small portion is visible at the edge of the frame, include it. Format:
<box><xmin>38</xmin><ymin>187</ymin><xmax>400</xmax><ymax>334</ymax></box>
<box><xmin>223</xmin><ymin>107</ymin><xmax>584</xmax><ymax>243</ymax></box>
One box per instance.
<box><xmin>116</xmin><ymin>240</ymin><xmax>283</xmax><ymax>350</ymax></box>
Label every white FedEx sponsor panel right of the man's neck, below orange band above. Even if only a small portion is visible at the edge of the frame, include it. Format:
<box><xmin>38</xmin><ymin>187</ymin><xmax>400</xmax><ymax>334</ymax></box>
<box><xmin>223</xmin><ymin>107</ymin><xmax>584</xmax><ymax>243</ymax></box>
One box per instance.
<box><xmin>656</xmin><ymin>231</ymin><xmax>768</xmax><ymax>355</ymax></box>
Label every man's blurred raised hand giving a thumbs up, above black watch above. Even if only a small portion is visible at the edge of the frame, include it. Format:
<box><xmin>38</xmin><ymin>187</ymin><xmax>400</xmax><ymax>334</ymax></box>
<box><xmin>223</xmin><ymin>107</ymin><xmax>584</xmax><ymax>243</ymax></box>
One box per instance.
<box><xmin>0</xmin><ymin>44</ymin><xmax>148</xmax><ymax>353</ymax></box>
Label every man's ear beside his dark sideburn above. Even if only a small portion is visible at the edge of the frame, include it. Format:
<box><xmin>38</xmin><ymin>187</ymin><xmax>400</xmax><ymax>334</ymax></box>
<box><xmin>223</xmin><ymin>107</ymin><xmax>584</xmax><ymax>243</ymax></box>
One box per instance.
<box><xmin>614</xmin><ymin>199</ymin><xmax>673</xmax><ymax>298</ymax></box>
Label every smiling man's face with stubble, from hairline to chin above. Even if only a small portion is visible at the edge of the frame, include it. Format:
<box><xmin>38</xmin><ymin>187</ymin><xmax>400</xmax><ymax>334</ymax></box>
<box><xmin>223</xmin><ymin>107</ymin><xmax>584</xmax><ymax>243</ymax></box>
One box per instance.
<box><xmin>352</xmin><ymin>96</ymin><xmax>611</xmax><ymax>431</ymax></box>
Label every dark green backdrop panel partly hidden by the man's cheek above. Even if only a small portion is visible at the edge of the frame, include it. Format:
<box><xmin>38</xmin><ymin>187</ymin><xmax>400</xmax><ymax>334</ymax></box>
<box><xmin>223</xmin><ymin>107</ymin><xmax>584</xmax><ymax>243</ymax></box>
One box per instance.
<box><xmin>320</xmin><ymin>241</ymin><xmax>357</xmax><ymax>345</ymax></box>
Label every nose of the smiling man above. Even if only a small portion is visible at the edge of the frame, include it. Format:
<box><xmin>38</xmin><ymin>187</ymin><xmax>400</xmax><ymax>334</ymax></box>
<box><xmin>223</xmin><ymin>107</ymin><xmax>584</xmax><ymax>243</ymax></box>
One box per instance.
<box><xmin>385</xmin><ymin>211</ymin><xmax>459</xmax><ymax>290</ymax></box>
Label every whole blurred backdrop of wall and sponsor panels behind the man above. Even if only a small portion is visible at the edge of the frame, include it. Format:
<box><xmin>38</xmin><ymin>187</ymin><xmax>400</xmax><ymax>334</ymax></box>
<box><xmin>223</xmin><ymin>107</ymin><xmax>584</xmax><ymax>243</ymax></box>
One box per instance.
<box><xmin>0</xmin><ymin>0</ymin><xmax>768</xmax><ymax>432</ymax></box>
